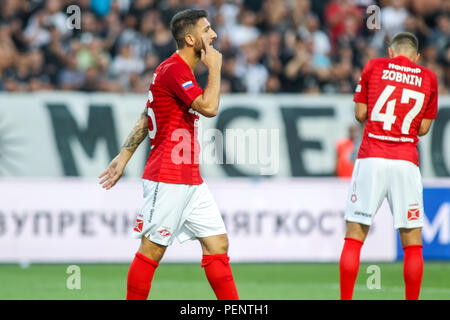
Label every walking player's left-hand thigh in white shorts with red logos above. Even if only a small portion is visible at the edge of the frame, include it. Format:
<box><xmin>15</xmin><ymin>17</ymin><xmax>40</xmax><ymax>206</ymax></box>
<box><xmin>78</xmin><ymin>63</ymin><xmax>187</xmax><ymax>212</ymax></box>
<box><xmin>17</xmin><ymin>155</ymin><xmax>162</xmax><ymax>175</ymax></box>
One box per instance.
<box><xmin>133</xmin><ymin>180</ymin><xmax>192</xmax><ymax>246</ymax></box>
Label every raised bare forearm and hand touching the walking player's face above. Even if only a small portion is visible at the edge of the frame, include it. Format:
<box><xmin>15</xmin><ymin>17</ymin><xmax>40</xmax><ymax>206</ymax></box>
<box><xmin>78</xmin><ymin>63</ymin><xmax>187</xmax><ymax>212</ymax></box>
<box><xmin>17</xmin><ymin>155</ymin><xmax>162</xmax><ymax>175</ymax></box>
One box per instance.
<box><xmin>191</xmin><ymin>36</ymin><xmax>222</xmax><ymax>118</ymax></box>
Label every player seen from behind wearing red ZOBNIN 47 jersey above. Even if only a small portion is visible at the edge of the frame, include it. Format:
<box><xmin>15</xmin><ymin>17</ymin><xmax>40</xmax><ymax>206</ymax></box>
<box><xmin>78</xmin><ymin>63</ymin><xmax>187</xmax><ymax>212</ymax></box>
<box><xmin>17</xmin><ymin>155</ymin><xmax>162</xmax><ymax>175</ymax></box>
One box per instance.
<box><xmin>339</xmin><ymin>32</ymin><xmax>438</xmax><ymax>300</ymax></box>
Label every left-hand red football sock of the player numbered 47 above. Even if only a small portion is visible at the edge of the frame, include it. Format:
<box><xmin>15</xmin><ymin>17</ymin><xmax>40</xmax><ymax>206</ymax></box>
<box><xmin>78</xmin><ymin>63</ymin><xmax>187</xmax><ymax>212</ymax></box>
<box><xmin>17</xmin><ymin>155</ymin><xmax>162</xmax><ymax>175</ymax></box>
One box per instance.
<box><xmin>339</xmin><ymin>238</ymin><xmax>364</xmax><ymax>300</ymax></box>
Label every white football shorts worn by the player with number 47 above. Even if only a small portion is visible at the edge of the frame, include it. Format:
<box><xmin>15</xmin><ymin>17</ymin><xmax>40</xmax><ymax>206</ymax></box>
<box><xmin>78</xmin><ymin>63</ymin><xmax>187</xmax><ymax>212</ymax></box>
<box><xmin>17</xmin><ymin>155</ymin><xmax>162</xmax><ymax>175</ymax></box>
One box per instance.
<box><xmin>345</xmin><ymin>158</ymin><xmax>424</xmax><ymax>229</ymax></box>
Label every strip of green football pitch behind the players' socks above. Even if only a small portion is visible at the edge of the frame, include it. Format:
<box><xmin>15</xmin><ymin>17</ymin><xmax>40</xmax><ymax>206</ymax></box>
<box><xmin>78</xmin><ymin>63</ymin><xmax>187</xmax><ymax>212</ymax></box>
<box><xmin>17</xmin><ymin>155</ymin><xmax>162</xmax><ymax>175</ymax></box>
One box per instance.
<box><xmin>0</xmin><ymin>262</ymin><xmax>450</xmax><ymax>300</ymax></box>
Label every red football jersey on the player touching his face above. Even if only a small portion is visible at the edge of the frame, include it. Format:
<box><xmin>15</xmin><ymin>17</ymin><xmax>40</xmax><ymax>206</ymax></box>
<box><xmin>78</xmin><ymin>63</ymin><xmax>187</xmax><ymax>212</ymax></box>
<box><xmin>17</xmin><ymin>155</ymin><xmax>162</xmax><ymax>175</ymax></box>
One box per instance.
<box><xmin>142</xmin><ymin>53</ymin><xmax>203</xmax><ymax>185</ymax></box>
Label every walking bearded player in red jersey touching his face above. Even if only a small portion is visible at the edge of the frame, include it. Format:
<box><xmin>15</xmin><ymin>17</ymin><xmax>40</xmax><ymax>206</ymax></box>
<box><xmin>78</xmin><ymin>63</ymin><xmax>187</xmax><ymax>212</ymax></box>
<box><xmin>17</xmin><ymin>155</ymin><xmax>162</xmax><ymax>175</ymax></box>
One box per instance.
<box><xmin>100</xmin><ymin>9</ymin><xmax>239</xmax><ymax>300</ymax></box>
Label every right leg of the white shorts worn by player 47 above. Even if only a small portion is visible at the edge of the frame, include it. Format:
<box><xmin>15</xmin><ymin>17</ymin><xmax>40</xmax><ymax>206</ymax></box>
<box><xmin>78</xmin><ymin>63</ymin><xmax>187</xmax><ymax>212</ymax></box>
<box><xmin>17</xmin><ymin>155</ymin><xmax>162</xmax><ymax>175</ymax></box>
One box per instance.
<box><xmin>388</xmin><ymin>160</ymin><xmax>424</xmax><ymax>229</ymax></box>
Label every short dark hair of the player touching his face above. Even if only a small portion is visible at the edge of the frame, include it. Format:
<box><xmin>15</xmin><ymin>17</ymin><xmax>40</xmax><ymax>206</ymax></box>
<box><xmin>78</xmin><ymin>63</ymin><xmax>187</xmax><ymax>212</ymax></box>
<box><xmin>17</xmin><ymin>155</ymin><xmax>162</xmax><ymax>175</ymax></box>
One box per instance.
<box><xmin>170</xmin><ymin>9</ymin><xmax>208</xmax><ymax>49</ymax></box>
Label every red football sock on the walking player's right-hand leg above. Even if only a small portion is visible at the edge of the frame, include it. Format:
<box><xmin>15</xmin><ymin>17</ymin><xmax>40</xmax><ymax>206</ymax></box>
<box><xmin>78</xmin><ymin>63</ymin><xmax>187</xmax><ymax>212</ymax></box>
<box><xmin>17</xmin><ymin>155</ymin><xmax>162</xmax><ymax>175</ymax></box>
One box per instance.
<box><xmin>201</xmin><ymin>253</ymin><xmax>239</xmax><ymax>300</ymax></box>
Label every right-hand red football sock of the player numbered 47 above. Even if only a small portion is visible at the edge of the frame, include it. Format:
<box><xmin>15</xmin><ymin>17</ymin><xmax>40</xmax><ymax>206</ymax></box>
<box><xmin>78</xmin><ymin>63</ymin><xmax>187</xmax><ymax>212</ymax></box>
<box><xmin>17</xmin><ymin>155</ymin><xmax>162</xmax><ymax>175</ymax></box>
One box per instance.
<box><xmin>403</xmin><ymin>245</ymin><xmax>423</xmax><ymax>300</ymax></box>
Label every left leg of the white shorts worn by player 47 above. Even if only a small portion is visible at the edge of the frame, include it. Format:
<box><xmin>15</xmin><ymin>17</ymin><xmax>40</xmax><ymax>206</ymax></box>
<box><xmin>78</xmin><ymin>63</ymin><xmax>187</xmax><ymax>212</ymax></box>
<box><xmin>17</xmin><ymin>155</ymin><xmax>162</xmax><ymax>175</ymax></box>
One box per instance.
<box><xmin>345</xmin><ymin>158</ymin><xmax>388</xmax><ymax>226</ymax></box>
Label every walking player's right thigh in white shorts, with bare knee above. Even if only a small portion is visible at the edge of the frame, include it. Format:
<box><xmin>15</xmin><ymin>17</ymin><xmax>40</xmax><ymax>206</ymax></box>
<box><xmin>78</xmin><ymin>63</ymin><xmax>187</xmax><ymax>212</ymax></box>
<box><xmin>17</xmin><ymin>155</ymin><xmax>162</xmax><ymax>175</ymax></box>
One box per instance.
<box><xmin>178</xmin><ymin>183</ymin><xmax>228</xmax><ymax>250</ymax></box>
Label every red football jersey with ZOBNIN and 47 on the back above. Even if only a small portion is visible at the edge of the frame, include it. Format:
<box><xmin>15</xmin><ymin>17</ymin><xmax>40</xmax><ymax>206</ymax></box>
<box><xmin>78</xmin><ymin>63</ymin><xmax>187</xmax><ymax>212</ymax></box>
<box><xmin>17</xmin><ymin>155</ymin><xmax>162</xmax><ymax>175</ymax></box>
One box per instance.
<box><xmin>353</xmin><ymin>56</ymin><xmax>438</xmax><ymax>165</ymax></box>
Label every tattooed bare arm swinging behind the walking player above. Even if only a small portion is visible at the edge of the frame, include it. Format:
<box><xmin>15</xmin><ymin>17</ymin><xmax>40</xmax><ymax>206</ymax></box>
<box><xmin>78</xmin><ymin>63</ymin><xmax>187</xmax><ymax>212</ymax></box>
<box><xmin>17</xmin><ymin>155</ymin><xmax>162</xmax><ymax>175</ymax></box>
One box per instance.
<box><xmin>99</xmin><ymin>107</ymin><xmax>148</xmax><ymax>190</ymax></box>
